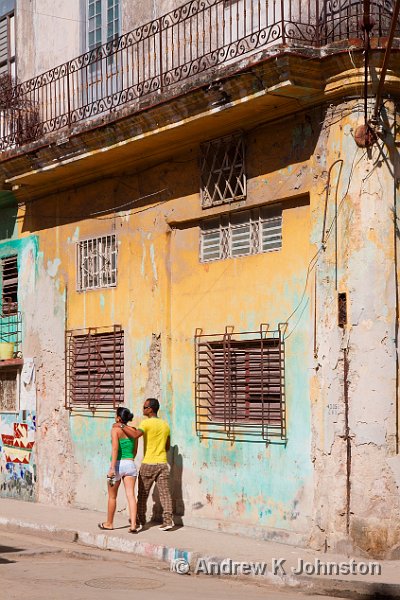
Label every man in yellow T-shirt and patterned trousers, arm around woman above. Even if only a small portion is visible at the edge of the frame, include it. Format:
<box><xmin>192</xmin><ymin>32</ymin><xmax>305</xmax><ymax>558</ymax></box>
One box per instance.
<box><xmin>124</xmin><ymin>398</ymin><xmax>174</xmax><ymax>531</ymax></box>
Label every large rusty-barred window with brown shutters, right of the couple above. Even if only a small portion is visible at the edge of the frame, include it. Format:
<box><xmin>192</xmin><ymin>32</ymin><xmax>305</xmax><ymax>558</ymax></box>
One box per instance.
<box><xmin>195</xmin><ymin>323</ymin><xmax>286</xmax><ymax>443</ymax></box>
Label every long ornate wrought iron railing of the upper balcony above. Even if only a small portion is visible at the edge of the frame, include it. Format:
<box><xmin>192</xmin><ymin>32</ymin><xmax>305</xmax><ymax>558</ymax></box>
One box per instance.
<box><xmin>0</xmin><ymin>0</ymin><xmax>394</xmax><ymax>152</ymax></box>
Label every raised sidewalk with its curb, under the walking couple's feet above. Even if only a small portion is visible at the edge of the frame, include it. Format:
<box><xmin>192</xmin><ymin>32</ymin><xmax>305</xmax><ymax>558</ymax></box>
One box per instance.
<box><xmin>0</xmin><ymin>499</ymin><xmax>400</xmax><ymax>599</ymax></box>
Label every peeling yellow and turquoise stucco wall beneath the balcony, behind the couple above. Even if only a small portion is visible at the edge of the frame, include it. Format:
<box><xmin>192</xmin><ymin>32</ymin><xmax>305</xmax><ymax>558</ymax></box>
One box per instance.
<box><xmin>3</xmin><ymin>102</ymin><xmax>400</xmax><ymax>556</ymax></box>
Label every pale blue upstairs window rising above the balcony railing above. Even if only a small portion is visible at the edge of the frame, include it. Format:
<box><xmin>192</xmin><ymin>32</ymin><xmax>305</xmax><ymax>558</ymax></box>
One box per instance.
<box><xmin>88</xmin><ymin>0</ymin><xmax>120</xmax><ymax>50</ymax></box>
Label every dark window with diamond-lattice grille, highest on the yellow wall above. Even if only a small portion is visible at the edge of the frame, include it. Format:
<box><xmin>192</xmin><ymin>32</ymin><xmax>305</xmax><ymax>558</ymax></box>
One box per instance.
<box><xmin>200</xmin><ymin>133</ymin><xmax>247</xmax><ymax>208</ymax></box>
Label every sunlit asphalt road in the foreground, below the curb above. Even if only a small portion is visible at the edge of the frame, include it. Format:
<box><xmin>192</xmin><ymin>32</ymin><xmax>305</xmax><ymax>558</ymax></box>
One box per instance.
<box><xmin>0</xmin><ymin>530</ymin><xmax>346</xmax><ymax>600</ymax></box>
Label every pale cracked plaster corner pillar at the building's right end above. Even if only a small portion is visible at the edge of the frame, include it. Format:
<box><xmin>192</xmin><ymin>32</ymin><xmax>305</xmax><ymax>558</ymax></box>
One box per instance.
<box><xmin>311</xmin><ymin>103</ymin><xmax>400</xmax><ymax>557</ymax></box>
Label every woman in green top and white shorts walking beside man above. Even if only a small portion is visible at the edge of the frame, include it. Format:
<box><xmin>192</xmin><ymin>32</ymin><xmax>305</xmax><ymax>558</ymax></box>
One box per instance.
<box><xmin>99</xmin><ymin>406</ymin><xmax>141</xmax><ymax>533</ymax></box>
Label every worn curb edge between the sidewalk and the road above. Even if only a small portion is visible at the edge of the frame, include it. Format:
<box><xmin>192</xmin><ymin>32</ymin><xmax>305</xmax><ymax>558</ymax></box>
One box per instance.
<box><xmin>0</xmin><ymin>517</ymin><xmax>400</xmax><ymax>600</ymax></box>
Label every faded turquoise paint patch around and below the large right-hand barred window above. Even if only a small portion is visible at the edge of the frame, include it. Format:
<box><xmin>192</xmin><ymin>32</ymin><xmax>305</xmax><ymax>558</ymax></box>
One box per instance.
<box><xmin>171</xmin><ymin>326</ymin><xmax>313</xmax><ymax>532</ymax></box>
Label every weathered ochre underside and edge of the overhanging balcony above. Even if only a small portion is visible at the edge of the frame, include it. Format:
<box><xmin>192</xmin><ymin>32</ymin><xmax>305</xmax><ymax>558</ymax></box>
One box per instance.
<box><xmin>0</xmin><ymin>48</ymin><xmax>400</xmax><ymax>201</ymax></box>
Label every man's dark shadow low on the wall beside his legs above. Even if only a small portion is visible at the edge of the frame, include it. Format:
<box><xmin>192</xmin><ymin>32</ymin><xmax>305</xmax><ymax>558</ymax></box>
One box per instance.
<box><xmin>152</xmin><ymin>445</ymin><xmax>185</xmax><ymax>525</ymax></box>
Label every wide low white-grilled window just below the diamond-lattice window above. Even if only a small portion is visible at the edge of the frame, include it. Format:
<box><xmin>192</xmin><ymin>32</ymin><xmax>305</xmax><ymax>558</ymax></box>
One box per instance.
<box><xmin>200</xmin><ymin>207</ymin><xmax>282</xmax><ymax>262</ymax></box>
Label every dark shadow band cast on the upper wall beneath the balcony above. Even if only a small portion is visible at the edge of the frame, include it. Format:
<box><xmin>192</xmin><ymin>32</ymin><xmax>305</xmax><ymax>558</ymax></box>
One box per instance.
<box><xmin>22</xmin><ymin>107</ymin><xmax>324</xmax><ymax>232</ymax></box>
